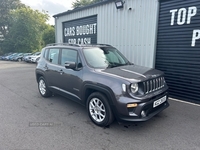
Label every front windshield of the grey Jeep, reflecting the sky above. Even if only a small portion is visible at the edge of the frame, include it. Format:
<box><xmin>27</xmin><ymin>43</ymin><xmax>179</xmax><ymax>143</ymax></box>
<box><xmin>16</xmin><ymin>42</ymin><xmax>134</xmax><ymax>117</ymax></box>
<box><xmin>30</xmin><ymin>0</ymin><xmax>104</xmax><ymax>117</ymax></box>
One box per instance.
<box><xmin>83</xmin><ymin>47</ymin><xmax>129</xmax><ymax>68</ymax></box>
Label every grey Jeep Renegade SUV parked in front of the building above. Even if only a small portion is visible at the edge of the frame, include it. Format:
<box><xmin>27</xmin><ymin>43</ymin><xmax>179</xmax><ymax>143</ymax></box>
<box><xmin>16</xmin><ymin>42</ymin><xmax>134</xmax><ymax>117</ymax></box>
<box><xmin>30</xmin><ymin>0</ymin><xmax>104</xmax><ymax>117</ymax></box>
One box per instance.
<box><xmin>36</xmin><ymin>43</ymin><xmax>169</xmax><ymax>126</ymax></box>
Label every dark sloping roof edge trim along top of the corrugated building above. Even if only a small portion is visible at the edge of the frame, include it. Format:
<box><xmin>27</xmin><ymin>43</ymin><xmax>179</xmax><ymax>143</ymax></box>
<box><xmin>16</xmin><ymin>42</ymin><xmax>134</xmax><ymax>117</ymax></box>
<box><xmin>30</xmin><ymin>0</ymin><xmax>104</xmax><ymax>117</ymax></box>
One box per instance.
<box><xmin>53</xmin><ymin>0</ymin><xmax>115</xmax><ymax>18</ymax></box>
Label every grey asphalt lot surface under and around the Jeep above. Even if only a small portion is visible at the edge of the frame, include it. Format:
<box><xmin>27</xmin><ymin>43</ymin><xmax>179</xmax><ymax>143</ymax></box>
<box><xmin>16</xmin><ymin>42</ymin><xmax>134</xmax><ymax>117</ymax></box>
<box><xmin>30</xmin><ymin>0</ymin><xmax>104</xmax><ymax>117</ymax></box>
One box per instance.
<box><xmin>0</xmin><ymin>61</ymin><xmax>200</xmax><ymax>150</ymax></box>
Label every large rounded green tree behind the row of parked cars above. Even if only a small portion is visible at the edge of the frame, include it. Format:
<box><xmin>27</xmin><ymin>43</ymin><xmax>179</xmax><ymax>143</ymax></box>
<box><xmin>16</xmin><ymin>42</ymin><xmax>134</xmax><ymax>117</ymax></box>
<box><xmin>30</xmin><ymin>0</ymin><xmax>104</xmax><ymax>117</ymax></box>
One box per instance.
<box><xmin>3</xmin><ymin>7</ymin><xmax>49</xmax><ymax>52</ymax></box>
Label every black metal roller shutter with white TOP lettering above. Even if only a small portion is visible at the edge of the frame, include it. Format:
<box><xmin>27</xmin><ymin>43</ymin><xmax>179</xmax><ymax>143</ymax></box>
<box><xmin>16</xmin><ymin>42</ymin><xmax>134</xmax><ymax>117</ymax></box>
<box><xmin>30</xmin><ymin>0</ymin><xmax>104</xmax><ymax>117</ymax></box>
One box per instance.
<box><xmin>155</xmin><ymin>0</ymin><xmax>200</xmax><ymax>103</ymax></box>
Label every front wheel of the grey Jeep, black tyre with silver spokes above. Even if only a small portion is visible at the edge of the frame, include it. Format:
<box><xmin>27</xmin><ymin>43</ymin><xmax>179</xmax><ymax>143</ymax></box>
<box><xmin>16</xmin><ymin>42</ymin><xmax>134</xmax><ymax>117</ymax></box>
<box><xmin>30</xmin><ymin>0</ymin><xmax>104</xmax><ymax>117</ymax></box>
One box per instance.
<box><xmin>87</xmin><ymin>92</ymin><xmax>114</xmax><ymax>127</ymax></box>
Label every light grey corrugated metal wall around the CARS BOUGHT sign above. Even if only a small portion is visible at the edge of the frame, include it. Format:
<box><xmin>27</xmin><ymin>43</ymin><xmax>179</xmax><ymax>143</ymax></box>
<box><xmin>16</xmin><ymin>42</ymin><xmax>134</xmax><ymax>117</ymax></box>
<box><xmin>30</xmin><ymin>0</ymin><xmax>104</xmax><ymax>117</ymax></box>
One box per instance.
<box><xmin>55</xmin><ymin>0</ymin><xmax>159</xmax><ymax>67</ymax></box>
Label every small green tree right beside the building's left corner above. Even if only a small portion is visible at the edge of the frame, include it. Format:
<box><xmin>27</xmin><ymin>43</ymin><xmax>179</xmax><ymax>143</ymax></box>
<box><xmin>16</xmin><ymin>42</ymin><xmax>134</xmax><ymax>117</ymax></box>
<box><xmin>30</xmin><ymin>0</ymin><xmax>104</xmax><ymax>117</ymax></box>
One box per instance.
<box><xmin>42</xmin><ymin>25</ymin><xmax>55</xmax><ymax>46</ymax></box>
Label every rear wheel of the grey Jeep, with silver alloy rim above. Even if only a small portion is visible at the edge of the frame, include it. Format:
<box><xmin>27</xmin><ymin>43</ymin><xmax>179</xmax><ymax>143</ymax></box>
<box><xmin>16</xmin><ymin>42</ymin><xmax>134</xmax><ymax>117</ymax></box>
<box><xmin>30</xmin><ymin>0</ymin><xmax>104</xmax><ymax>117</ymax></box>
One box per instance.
<box><xmin>38</xmin><ymin>77</ymin><xmax>52</xmax><ymax>97</ymax></box>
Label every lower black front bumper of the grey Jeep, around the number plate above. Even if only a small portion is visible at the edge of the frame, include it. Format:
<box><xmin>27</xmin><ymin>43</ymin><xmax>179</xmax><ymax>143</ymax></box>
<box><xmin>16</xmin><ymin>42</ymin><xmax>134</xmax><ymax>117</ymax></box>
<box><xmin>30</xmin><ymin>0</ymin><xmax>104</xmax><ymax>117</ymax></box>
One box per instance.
<box><xmin>113</xmin><ymin>92</ymin><xmax>169</xmax><ymax>122</ymax></box>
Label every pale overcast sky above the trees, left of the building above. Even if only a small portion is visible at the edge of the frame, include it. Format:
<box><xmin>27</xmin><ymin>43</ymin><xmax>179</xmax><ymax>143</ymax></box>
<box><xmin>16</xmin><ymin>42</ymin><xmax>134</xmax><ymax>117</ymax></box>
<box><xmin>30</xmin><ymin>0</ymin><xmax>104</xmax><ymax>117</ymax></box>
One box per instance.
<box><xmin>21</xmin><ymin>0</ymin><xmax>75</xmax><ymax>24</ymax></box>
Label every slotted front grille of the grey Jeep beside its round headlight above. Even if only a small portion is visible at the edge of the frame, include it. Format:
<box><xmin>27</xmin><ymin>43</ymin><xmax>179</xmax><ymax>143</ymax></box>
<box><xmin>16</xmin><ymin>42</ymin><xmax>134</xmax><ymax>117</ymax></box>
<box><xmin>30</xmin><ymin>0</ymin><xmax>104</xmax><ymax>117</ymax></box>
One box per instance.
<box><xmin>143</xmin><ymin>77</ymin><xmax>165</xmax><ymax>94</ymax></box>
